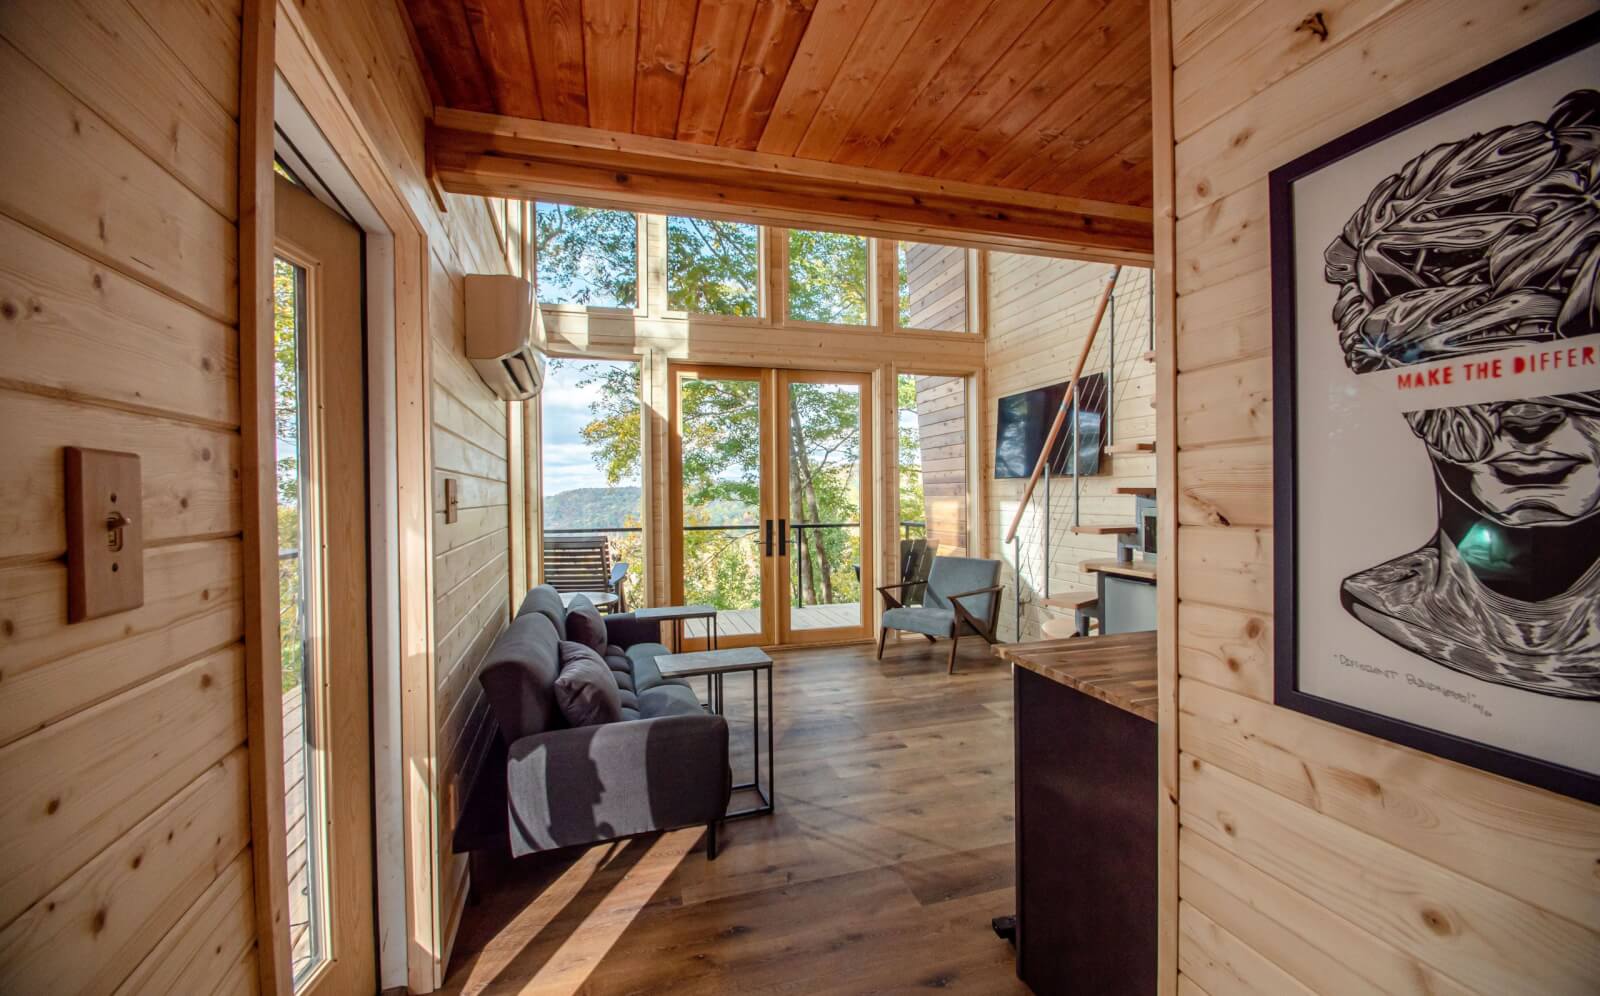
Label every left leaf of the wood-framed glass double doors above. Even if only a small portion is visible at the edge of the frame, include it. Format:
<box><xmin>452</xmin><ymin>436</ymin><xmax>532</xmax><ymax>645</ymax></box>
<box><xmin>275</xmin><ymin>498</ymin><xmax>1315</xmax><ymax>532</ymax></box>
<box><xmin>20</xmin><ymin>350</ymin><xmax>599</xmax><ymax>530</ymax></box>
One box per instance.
<box><xmin>669</xmin><ymin>363</ymin><xmax>778</xmax><ymax>647</ymax></box>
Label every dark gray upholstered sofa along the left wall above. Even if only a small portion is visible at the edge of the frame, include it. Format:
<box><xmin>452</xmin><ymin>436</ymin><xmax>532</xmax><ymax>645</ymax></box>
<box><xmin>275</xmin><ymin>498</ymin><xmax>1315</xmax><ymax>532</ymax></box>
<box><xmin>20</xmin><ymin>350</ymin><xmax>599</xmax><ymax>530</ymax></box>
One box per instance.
<box><xmin>453</xmin><ymin>584</ymin><xmax>733</xmax><ymax>858</ymax></box>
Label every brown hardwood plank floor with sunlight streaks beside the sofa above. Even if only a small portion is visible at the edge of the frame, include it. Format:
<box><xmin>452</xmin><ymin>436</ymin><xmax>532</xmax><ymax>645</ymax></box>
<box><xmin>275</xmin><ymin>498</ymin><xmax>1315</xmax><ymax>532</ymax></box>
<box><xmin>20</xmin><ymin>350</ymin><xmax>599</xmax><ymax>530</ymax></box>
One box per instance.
<box><xmin>443</xmin><ymin>639</ymin><xmax>1027</xmax><ymax>996</ymax></box>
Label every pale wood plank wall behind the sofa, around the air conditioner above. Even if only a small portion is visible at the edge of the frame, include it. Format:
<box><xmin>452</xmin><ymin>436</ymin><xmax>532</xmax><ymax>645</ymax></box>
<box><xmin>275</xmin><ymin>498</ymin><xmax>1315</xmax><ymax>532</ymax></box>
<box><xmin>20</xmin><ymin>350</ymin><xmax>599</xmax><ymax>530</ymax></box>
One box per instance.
<box><xmin>280</xmin><ymin>3</ymin><xmax>522</xmax><ymax>951</ymax></box>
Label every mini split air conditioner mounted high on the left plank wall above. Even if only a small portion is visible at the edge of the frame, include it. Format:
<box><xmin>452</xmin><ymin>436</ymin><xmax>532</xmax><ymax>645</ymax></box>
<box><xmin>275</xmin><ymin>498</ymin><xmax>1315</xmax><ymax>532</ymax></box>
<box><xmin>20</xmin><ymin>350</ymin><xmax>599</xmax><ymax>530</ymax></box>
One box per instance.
<box><xmin>467</xmin><ymin>274</ymin><xmax>544</xmax><ymax>402</ymax></box>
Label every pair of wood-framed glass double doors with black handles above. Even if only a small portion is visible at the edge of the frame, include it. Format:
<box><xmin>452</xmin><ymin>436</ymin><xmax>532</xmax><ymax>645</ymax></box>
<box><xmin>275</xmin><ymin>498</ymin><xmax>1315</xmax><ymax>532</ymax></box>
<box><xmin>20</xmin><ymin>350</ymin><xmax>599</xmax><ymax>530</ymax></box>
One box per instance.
<box><xmin>669</xmin><ymin>363</ymin><xmax>874</xmax><ymax>647</ymax></box>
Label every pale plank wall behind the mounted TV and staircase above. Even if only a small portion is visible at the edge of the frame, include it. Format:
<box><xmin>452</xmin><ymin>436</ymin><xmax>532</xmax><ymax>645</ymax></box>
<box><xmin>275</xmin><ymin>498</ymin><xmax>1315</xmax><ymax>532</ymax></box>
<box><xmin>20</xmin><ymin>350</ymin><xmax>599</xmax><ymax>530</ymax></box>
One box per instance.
<box><xmin>979</xmin><ymin>253</ymin><xmax>1155</xmax><ymax>641</ymax></box>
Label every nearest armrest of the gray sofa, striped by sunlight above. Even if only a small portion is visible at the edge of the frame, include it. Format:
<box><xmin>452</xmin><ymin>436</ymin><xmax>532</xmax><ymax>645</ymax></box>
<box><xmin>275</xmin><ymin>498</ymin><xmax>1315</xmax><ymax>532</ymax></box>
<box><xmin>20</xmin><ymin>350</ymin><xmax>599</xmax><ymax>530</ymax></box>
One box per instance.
<box><xmin>506</xmin><ymin>714</ymin><xmax>733</xmax><ymax>857</ymax></box>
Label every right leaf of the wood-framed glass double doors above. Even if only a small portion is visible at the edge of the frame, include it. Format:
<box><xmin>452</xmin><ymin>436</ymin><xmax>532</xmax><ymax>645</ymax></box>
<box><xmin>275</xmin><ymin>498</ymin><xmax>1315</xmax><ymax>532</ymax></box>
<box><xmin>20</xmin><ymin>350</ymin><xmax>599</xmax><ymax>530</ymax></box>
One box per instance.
<box><xmin>773</xmin><ymin>370</ymin><xmax>874</xmax><ymax>644</ymax></box>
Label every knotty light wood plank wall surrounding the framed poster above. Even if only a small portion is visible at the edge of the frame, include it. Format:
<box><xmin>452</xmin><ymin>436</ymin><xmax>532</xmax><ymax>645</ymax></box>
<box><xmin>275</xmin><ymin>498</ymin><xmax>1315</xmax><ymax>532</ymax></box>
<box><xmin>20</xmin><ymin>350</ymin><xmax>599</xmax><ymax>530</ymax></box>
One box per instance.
<box><xmin>1157</xmin><ymin>0</ymin><xmax>1600</xmax><ymax>994</ymax></box>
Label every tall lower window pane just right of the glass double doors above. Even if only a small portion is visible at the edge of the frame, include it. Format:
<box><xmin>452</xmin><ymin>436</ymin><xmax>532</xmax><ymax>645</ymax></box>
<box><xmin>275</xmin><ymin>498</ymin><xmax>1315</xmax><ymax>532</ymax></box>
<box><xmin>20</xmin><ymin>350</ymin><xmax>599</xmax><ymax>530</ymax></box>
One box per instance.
<box><xmin>898</xmin><ymin>373</ymin><xmax>968</xmax><ymax>599</ymax></box>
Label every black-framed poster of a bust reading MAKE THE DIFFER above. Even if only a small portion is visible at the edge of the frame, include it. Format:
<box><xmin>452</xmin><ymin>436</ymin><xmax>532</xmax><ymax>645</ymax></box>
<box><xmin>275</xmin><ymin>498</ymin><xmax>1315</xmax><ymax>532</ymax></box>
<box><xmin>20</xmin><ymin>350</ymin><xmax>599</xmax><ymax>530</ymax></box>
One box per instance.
<box><xmin>1269</xmin><ymin>16</ymin><xmax>1600</xmax><ymax>802</ymax></box>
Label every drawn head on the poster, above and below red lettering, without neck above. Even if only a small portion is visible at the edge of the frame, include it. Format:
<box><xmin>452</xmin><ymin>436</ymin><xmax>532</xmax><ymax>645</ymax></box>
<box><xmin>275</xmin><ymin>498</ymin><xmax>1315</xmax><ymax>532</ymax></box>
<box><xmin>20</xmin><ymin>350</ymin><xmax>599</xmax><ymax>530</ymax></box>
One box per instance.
<box><xmin>1323</xmin><ymin>90</ymin><xmax>1600</xmax><ymax>525</ymax></box>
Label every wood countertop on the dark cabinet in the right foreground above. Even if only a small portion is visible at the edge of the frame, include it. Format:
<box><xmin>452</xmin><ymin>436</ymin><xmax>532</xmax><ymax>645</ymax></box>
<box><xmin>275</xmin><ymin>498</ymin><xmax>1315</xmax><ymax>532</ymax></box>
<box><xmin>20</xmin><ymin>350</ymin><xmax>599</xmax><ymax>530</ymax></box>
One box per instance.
<box><xmin>994</xmin><ymin>631</ymin><xmax>1157</xmax><ymax>722</ymax></box>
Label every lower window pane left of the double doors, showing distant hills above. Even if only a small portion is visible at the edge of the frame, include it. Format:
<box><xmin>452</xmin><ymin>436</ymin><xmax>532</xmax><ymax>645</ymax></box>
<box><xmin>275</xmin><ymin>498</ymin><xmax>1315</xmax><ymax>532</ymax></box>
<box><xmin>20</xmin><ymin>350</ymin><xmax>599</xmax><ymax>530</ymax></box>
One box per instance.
<box><xmin>539</xmin><ymin>359</ymin><xmax>645</xmax><ymax>608</ymax></box>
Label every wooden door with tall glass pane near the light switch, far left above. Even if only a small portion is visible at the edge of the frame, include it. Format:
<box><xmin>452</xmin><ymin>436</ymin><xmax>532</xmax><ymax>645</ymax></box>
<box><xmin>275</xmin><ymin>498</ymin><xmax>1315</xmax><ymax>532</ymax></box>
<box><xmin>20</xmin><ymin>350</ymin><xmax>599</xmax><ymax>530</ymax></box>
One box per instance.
<box><xmin>274</xmin><ymin>176</ymin><xmax>378</xmax><ymax>996</ymax></box>
